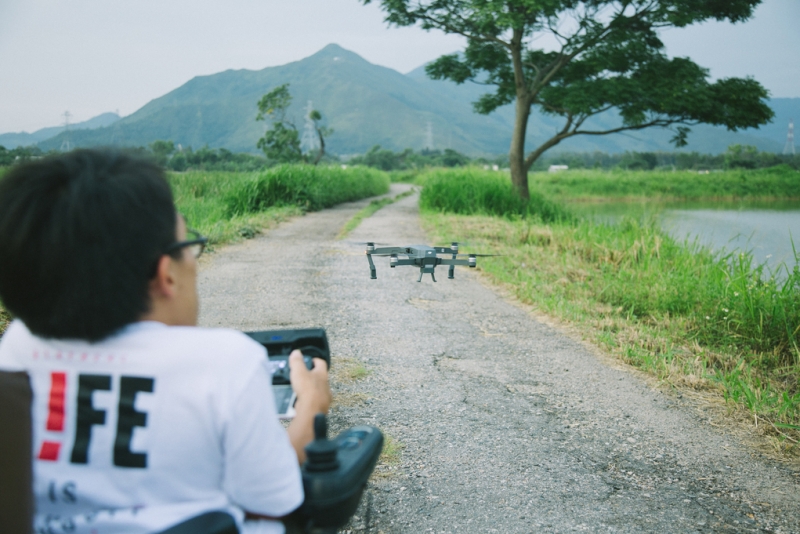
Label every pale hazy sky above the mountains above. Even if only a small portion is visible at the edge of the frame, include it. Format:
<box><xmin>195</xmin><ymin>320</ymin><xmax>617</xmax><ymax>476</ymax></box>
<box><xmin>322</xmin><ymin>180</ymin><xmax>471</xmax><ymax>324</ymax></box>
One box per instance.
<box><xmin>0</xmin><ymin>0</ymin><xmax>800</xmax><ymax>133</ymax></box>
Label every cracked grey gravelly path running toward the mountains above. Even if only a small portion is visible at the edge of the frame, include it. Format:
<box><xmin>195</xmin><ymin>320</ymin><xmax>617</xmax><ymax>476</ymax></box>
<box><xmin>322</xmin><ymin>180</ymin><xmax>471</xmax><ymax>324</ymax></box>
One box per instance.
<box><xmin>199</xmin><ymin>184</ymin><xmax>800</xmax><ymax>534</ymax></box>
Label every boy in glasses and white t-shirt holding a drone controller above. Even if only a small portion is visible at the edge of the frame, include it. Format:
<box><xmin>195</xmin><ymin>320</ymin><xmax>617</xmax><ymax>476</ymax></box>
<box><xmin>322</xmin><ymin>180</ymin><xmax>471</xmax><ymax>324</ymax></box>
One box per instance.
<box><xmin>0</xmin><ymin>150</ymin><xmax>330</xmax><ymax>534</ymax></box>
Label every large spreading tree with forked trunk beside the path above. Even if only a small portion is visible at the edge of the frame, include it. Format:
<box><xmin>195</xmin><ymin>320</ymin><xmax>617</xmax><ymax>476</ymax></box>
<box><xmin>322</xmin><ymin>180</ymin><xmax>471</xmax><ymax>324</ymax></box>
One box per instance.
<box><xmin>362</xmin><ymin>0</ymin><xmax>773</xmax><ymax>198</ymax></box>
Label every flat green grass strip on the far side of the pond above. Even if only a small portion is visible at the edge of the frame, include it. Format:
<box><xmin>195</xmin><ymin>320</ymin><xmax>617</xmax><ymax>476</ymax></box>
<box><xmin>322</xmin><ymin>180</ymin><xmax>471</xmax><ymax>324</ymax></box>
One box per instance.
<box><xmin>532</xmin><ymin>165</ymin><xmax>800</xmax><ymax>200</ymax></box>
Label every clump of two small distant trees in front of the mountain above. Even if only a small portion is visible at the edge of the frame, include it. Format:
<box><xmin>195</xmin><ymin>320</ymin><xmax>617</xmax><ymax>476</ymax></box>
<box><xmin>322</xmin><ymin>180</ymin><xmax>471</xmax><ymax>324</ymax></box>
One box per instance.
<box><xmin>256</xmin><ymin>83</ymin><xmax>333</xmax><ymax>165</ymax></box>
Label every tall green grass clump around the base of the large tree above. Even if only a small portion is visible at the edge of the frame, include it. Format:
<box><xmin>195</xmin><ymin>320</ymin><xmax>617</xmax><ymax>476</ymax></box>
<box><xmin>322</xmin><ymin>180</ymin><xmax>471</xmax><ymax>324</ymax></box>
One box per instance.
<box><xmin>419</xmin><ymin>167</ymin><xmax>570</xmax><ymax>222</ymax></box>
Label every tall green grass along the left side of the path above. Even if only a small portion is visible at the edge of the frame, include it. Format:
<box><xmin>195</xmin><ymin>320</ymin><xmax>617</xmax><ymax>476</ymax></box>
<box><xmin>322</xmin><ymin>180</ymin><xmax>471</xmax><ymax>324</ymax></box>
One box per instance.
<box><xmin>169</xmin><ymin>165</ymin><xmax>389</xmax><ymax>245</ymax></box>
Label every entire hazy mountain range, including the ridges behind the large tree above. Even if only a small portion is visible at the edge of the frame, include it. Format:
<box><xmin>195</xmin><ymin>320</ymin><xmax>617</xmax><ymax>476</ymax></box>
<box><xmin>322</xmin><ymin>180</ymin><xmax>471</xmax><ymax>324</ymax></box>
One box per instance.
<box><xmin>34</xmin><ymin>44</ymin><xmax>800</xmax><ymax>155</ymax></box>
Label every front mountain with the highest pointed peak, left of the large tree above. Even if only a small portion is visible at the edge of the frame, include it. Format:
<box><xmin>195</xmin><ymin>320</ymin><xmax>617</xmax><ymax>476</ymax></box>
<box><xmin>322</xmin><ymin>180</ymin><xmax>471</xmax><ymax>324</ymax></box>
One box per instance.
<box><xmin>40</xmin><ymin>45</ymin><xmax>520</xmax><ymax>154</ymax></box>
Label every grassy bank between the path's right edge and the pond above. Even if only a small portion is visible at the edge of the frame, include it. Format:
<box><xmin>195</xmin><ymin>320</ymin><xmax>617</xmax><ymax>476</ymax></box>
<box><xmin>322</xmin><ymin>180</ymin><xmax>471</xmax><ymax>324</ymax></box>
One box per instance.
<box><xmin>423</xmin><ymin>169</ymin><xmax>800</xmax><ymax>448</ymax></box>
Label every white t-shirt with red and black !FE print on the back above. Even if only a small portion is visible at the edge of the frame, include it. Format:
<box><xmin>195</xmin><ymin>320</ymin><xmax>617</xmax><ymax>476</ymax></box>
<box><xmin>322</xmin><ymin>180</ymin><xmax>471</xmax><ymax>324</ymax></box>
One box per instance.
<box><xmin>0</xmin><ymin>320</ymin><xmax>303</xmax><ymax>534</ymax></box>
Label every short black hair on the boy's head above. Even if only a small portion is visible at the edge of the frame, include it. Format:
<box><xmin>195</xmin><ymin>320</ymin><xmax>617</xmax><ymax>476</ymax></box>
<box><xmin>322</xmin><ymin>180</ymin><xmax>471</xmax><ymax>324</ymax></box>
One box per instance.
<box><xmin>0</xmin><ymin>149</ymin><xmax>177</xmax><ymax>341</ymax></box>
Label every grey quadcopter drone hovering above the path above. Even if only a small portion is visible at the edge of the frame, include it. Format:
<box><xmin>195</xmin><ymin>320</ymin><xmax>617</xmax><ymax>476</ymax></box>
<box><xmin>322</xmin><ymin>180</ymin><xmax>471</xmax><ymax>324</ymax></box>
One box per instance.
<box><xmin>365</xmin><ymin>241</ymin><xmax>494</xmax><ymax>282</ymax></box>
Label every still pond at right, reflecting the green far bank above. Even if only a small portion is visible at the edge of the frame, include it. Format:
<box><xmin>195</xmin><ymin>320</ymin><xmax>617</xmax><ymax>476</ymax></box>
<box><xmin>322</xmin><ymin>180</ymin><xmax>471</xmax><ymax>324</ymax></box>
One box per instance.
<box><xmin>569</xmin><ymin>201</ymin><xmax>800</xmax><ymax>271</ymax></box>
